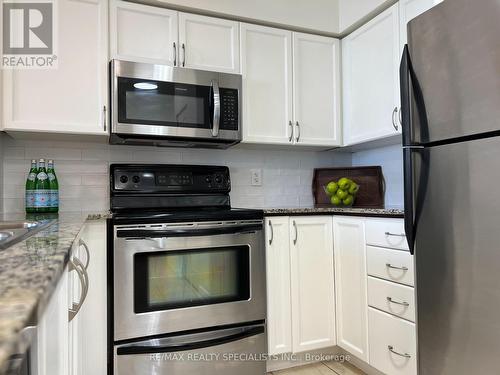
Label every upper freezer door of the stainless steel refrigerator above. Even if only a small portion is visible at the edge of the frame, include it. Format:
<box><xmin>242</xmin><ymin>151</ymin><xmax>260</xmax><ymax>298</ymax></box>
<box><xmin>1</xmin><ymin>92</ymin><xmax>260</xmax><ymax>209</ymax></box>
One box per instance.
<box><xmin>401</xmin><ymin>0</ymin><xmax>500</xmax><ymax>144</ymax></box>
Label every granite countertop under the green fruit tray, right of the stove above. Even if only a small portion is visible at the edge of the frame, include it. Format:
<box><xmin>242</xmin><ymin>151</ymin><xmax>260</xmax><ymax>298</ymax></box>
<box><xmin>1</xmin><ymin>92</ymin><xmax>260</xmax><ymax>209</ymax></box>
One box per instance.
<box><xmin>264</xmin><ymin>207</ymin><xmax>404</xmax><ymax>218</ymax></box>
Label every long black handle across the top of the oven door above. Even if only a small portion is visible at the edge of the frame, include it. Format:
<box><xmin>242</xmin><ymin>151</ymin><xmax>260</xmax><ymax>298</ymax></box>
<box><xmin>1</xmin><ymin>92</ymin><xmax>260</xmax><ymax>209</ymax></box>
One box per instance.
<box><xmin>116</xmin><ymin>224</ymin><xmax>262</xmax><ymax>239</ymax></box>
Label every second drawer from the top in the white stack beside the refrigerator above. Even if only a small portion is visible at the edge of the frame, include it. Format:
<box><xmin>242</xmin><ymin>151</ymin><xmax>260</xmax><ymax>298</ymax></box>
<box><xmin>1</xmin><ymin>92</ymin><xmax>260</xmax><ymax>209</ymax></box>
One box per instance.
<box><xmin>366</xmin><ymin>246</ymin><xmax>414</xmax><ymax>286</ymax></box>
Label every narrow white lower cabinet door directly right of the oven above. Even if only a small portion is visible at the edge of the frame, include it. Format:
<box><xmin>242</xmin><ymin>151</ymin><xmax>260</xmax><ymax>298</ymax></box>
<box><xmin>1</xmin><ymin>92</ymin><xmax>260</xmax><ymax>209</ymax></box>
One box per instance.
<box><xmin>265</xmin><ymin>216</ymin><xmax>292</xmax><ymax>355</ymax></box>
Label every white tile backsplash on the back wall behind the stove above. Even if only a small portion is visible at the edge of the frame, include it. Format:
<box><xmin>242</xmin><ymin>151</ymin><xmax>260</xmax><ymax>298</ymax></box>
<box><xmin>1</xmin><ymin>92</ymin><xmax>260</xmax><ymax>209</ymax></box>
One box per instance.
<box><xmin>3</xmin><ymin>137</ymin><xmax>351</xmax><ymax>212</ymax></box>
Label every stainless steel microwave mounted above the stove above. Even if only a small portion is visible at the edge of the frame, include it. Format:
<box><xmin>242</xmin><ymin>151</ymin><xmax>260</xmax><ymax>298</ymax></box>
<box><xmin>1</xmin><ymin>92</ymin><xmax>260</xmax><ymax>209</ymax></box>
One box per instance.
<box><xmin>110</xmin><ymin>60</ymin><xmax>242</xmax><ymax>148</ymax></box>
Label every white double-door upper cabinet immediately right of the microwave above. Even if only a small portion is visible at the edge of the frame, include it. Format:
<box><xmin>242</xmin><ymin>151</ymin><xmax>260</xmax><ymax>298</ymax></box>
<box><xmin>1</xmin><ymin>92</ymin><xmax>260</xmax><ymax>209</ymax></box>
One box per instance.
<box><xmin>240</xmin><ymin>24</ymin><xmax>341</xmax><ymax>147</ymax></box>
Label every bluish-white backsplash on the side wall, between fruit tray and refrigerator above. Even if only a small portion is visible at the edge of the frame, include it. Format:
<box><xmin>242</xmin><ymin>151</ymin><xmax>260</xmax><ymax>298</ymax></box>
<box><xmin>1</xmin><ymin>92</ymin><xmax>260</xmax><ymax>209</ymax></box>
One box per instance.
<box><xmin>352</xmin><ymin>145</ymin><xmax>404</xmax><ymax>208</ymax></box>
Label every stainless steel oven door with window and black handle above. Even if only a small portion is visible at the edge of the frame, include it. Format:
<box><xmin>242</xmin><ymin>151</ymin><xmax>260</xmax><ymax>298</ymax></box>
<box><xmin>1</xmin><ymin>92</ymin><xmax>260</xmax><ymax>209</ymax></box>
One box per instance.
<box><xmin>114</xmin><ymin>221</ymin><xmax>266</xmax><ymax>341</ymax></box>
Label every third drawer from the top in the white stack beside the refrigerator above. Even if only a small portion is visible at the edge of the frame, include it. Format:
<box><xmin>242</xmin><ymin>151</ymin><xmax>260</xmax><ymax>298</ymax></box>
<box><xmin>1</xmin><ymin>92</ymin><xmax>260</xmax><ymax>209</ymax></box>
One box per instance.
<box><xmin>368</xmin><ymin>277</ymin><xmax>415</xmax><ymax>322</ymax></box>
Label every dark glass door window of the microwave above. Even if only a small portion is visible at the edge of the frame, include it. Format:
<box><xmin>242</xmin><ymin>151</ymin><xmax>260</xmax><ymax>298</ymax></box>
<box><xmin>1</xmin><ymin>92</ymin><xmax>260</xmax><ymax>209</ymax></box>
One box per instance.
<box><xmin>118</xmin><ymin>77</ymin><xmax>212</xmax><ymax>129</ymax></box>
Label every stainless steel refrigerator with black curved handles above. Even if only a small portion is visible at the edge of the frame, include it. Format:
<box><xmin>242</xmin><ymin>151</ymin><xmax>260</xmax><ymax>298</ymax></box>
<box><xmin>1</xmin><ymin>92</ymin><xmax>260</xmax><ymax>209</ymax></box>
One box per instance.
<box><xmin>400</xmin><ymin>0</ymin><xmax>500</xmax><ymax>375</ymax></box>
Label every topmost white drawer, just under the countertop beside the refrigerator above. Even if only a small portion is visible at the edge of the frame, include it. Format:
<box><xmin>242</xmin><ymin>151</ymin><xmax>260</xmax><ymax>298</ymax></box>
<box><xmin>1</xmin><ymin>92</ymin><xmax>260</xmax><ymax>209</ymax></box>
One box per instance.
<box><xmin>366</xmin><ymin>219</ymin><xmax>408</xmax><ymax>250</ymax></box>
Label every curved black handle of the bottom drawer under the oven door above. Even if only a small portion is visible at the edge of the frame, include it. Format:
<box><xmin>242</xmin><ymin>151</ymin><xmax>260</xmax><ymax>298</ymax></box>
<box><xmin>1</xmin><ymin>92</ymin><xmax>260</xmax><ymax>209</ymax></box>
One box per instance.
<box><xmin>116</xmin><ymin>325</ymin><xmax>265</xmax><ymax>355</ymax></box>
